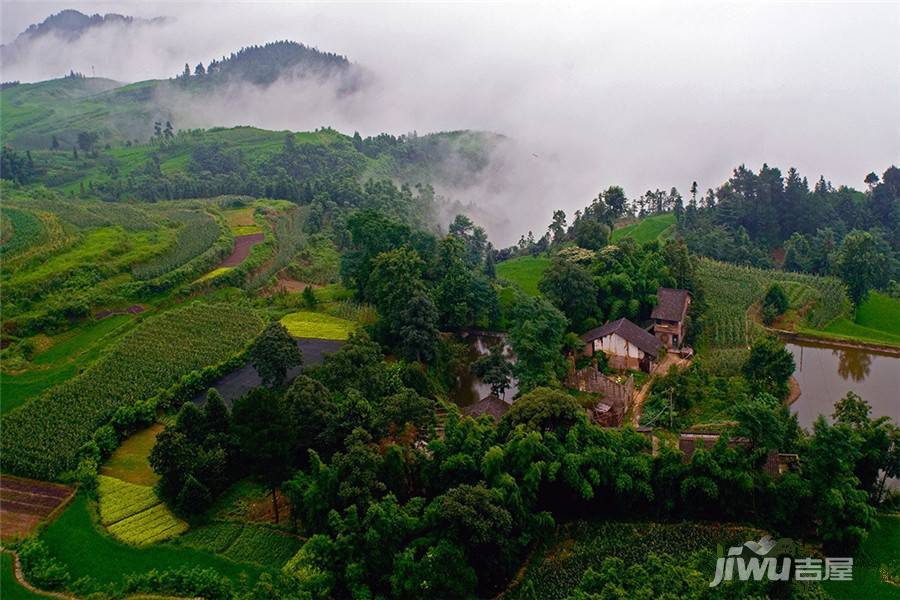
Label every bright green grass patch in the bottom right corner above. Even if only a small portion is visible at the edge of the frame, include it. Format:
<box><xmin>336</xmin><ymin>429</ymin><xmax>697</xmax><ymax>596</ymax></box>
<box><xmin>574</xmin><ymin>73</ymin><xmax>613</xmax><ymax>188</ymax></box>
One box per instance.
<box><xmin>823</xmin><ymin>515</ymin><xmax>900</xmax><ymax>600</ymax></box>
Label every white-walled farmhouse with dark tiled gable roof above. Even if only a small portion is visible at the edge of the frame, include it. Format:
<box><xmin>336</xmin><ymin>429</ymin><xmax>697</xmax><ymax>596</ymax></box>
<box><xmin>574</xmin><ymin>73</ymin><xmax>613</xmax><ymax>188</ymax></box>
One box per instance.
<box><xmin>581</xmin><ymin>318</ymin><xmax>660</xmax><ymax>373</ymax></box>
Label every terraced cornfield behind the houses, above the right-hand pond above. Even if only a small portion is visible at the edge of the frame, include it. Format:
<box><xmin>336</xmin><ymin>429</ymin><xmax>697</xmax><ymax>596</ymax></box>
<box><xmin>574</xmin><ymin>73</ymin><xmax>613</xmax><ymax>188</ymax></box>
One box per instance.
<box><xmin>699</xmin><ymin>258</ymin><xmax>849</xmax><ymax>347</ymax></box>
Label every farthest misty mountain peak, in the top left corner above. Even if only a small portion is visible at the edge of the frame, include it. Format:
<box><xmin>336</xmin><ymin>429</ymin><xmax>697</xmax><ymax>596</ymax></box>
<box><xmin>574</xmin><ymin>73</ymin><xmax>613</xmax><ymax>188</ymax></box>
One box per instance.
<box><xmin>0</xmin><ymin>9</ymin><xmax>169</xmax><ymax>64</ymax></box>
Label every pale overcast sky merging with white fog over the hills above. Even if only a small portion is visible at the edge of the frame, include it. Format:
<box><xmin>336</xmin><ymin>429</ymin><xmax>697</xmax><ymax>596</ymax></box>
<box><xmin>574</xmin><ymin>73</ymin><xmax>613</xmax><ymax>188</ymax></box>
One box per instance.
<box><xmin>2</xmin><ymin>0</ymin><xmax>900</xmax><ymax>241</ymax></box>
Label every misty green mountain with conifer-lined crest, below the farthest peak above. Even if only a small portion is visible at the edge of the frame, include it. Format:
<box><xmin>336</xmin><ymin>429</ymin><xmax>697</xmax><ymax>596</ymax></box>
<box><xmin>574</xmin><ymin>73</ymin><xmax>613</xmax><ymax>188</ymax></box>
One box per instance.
<box><xmin>2</xmin><ymin>36</ymin><xmax>366</xmax><ymax>149</ymax></box>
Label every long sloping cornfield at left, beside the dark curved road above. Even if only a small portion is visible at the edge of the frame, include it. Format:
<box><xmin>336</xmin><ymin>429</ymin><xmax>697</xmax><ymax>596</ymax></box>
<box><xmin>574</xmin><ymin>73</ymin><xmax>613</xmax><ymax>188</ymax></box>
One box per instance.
<box><xmin>0</xmin><ymin>303</ymin><xmax>262</xmax><ymax>479</ymax></box>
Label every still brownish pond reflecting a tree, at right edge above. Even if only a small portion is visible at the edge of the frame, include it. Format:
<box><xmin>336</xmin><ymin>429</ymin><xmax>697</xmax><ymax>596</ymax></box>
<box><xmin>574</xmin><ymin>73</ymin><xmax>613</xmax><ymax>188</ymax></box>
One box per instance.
<box><xmin>787</xmin><ymin>341</ymin><xmax>900</xmax><ymax>429</ymax></box>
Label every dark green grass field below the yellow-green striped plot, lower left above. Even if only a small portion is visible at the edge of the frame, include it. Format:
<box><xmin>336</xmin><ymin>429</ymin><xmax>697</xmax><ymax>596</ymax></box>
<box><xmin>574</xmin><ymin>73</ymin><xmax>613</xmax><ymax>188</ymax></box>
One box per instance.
<box><xmin>40</xmin><ymin>495</ymin><xmax>265</xmax><ymax>585</ymax></box>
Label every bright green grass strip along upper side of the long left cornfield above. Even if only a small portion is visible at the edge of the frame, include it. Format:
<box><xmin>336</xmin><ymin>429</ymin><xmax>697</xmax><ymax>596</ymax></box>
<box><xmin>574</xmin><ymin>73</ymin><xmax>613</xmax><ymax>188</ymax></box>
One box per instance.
<box><xmin>0</xmin><ymin>315</ymin><xmax>135</xmax><ymax>414</ymax></box>
